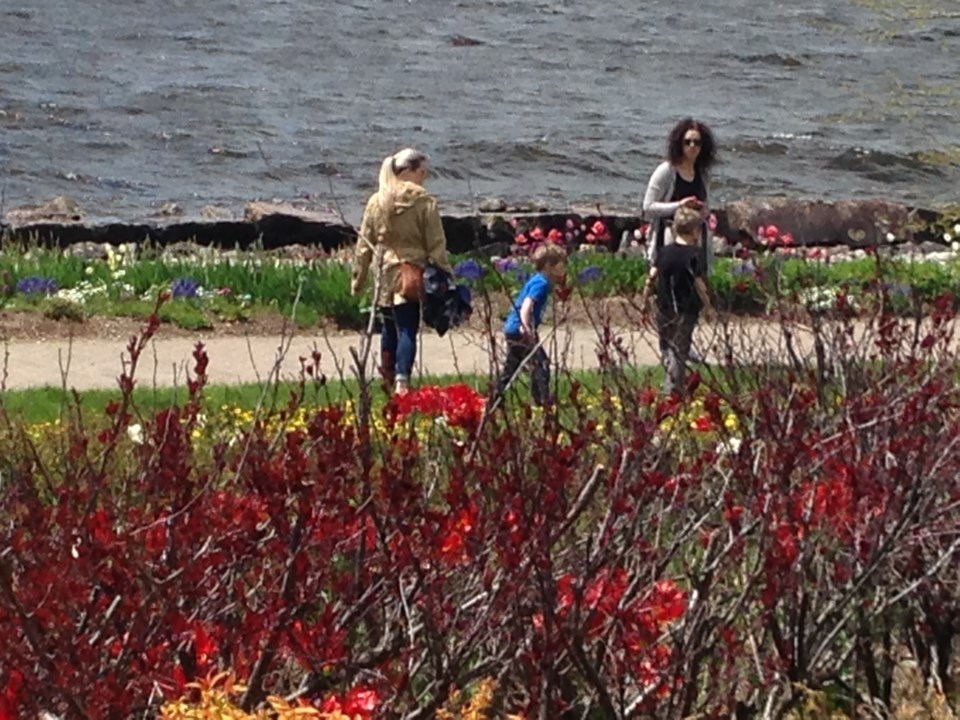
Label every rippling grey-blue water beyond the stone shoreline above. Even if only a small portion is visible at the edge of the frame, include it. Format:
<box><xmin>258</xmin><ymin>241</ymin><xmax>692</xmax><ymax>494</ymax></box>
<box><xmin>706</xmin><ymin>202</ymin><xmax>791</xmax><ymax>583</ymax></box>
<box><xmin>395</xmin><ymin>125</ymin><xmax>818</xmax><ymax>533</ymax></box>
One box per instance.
<box><xmin>0</xmin><ymin>0</ymin><xmax>960</xmax><ymax>218</ymax></box>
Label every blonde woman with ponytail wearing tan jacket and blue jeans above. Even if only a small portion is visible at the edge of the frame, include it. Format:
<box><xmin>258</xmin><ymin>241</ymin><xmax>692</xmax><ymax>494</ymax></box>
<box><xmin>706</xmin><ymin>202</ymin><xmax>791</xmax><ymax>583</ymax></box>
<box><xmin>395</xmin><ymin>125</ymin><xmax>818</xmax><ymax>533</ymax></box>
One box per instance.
<box><xmin>350</xmin><ymin>148</ymin><xmax>452</xmax><ymax>393</ymax></box>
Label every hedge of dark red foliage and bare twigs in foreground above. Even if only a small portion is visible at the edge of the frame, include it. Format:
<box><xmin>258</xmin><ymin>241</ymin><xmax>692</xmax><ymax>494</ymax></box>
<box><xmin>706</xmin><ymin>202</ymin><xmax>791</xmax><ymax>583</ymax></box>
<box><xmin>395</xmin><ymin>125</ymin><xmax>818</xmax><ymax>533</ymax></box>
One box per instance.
<box><xmin>0</xmin><ymin>306</ymin><xmax>960</xmax><ymax>720</ymax></box>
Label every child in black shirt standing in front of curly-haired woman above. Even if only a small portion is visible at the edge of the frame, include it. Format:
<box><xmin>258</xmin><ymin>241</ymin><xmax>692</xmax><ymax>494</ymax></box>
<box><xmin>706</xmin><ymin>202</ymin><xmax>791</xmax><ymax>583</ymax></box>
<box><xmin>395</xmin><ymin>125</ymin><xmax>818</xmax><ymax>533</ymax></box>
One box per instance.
<box><xmin>643</xmin><ymin>207</ymin><xmax>713</xmax><ymax>393</ymax></box>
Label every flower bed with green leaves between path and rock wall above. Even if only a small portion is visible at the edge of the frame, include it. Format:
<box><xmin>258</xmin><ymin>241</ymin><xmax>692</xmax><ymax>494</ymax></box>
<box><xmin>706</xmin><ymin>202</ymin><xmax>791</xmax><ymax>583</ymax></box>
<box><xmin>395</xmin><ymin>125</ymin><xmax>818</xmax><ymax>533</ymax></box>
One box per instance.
<box><xmin>0</xmin><ymin>240</ymin><xmax>960</xmax><ymax>329</ymax></box>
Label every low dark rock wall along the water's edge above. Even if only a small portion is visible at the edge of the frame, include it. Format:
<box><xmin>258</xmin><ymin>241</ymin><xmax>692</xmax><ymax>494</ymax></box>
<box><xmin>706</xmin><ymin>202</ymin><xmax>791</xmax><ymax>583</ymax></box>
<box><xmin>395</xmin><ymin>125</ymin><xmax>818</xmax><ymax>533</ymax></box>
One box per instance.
<box><xmin>0</xmin><ymin>197</ymin><xmax>957</xmax><ymax>254</ymax></box>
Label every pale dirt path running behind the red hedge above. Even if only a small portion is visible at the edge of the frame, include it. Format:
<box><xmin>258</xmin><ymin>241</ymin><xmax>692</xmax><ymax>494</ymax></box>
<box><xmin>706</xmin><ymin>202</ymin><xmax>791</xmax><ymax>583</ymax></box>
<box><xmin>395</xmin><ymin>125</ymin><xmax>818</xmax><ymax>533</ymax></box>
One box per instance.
<box><xmin>0</xmin><ymin>322</ymin><xmax>824</xmax><ymax>390</ymax></box>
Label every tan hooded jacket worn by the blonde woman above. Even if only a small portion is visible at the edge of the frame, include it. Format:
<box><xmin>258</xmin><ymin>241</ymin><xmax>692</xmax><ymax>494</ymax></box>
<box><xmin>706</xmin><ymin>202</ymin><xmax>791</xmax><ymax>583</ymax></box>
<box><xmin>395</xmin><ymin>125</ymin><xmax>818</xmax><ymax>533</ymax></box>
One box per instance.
<box><xmin>350</xmin><ymin>182</ymin><xmax>451</xmax><ymax>307</ymax></box>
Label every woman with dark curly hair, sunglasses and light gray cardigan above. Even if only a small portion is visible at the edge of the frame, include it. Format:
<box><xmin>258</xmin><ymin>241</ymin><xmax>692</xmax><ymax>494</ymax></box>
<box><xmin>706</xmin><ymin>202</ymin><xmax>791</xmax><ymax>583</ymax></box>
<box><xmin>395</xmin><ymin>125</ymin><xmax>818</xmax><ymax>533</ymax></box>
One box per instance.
<box><xmin>643</xmin><ymin>118</ymin><xmax>717</xmax><ymax>269</ymax></box>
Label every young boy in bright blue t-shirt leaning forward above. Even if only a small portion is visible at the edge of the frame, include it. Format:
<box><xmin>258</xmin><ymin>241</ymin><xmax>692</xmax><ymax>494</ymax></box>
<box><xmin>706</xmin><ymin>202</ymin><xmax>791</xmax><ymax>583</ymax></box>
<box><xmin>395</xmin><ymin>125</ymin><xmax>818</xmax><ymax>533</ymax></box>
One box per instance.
<box><xmin>494</xmin><ymin>243</ymin><xmax>567</xmax><ymax>405</ymax></box>
